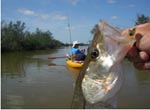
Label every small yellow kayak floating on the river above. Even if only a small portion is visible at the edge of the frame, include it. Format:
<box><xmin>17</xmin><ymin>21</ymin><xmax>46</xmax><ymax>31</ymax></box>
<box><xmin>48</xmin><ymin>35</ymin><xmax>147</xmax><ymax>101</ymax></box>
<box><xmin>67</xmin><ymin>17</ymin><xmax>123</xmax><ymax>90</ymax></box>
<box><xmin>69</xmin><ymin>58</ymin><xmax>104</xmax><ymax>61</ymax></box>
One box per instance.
<box><xmin>66</xmin><ymin>59</ymin><xmax>83</xmax><ymax>68</ymax></box>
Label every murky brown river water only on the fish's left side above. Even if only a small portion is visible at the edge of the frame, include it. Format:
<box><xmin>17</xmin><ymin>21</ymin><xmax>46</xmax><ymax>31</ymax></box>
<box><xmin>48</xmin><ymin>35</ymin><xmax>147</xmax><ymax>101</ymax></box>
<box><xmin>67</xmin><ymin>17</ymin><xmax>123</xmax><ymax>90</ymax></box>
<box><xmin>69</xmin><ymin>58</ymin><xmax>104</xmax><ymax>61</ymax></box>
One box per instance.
<box><xmin>1</xmin><ymin>49</ymin><xmax>74</xmax><ymax>109</ymax></box>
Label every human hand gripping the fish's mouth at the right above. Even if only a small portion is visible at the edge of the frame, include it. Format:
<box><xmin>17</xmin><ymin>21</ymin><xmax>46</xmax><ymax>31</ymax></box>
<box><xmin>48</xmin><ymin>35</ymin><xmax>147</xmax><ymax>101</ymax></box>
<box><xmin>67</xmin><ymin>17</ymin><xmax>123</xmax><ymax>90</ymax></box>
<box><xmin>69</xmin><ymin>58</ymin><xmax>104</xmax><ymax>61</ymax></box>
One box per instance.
<box><xmin>122</xmin><ymin>23</ymin><xmax>150</xmax><ymax>69</ymax></box>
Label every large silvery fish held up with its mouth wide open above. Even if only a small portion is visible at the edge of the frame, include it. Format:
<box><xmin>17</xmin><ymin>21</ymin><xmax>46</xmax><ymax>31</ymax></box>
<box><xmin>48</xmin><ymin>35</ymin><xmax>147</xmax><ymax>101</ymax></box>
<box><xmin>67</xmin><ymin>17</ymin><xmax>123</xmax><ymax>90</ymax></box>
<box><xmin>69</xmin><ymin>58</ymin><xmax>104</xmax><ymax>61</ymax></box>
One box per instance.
<box><xmin>71</xmin><ymin>21</ymin><xmax>136</xmax><ymax>108</ymax></box>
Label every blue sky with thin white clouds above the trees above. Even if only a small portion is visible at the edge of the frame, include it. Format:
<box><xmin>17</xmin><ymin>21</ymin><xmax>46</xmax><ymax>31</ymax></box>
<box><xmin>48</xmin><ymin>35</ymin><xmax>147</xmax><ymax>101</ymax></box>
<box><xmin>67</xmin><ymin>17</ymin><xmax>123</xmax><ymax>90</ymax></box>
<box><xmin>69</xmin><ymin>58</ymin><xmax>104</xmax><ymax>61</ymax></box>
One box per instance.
<box><xmin>1</xmin><ymin>0</ymin><xmax>150</xmax><ymax>43</ymax></box>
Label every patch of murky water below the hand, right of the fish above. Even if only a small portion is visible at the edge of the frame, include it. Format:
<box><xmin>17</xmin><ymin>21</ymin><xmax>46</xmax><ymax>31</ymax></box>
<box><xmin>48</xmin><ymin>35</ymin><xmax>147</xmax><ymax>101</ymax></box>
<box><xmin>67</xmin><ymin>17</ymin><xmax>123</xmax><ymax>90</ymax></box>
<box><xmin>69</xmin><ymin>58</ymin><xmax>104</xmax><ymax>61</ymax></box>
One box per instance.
<box><xmin>118</xmin><ymin>61</ymin><xmax>150</xmax><ymax>109</ymax></box>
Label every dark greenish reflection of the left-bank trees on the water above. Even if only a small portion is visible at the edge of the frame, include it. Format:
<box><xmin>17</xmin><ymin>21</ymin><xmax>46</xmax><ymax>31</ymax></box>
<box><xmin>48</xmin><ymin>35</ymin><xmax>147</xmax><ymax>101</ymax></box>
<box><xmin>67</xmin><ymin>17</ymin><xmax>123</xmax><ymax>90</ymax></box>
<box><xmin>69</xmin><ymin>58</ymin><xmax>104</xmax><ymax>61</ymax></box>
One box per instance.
<box><xmin>1</xmin><ymin>50</ymin><xmax>58</xmax><ymax>78</ymax></box>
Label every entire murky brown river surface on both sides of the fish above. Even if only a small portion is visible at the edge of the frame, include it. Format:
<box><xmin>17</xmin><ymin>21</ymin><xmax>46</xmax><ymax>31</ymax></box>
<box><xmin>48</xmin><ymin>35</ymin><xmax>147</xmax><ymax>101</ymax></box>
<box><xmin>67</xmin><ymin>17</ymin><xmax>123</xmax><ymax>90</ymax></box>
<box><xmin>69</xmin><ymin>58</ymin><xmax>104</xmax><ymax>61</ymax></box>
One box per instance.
<box><xmin>1</xmin><ymin>48</ymin><xmax>150</xmax><ymax>109</ymax></box>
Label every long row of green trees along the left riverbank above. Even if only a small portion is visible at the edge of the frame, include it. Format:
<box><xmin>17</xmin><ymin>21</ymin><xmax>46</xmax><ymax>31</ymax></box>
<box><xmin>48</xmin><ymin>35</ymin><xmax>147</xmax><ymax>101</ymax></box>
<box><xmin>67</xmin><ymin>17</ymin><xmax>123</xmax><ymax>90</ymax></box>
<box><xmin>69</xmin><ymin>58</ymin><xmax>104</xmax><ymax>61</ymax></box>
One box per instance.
<box><xmin>1</xmin><ymin>21</ymin><xmax>63</xmax><ymax>52</ymax></box>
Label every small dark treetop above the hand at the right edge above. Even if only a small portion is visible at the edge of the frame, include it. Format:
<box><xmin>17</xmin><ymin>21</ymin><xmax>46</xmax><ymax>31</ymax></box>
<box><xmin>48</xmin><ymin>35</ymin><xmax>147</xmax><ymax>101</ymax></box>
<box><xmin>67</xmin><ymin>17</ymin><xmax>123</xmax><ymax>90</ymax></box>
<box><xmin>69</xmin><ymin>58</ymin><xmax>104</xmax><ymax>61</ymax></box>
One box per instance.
<box><xmin>135</xmin><ymin>14</ymin><xmax>150</xmax><ymax>25</ymax></box>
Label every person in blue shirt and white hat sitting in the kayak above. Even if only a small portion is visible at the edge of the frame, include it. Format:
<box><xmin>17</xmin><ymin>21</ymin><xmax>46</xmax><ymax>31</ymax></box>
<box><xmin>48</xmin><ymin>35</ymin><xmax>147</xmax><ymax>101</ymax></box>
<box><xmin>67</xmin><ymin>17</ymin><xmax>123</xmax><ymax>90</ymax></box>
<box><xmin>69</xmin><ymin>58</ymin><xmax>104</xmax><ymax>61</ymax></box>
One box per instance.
<box><xmin>66</xmin><ymin>41</ymin><xmax>86</xmax><ymax>61</ymax></box>
